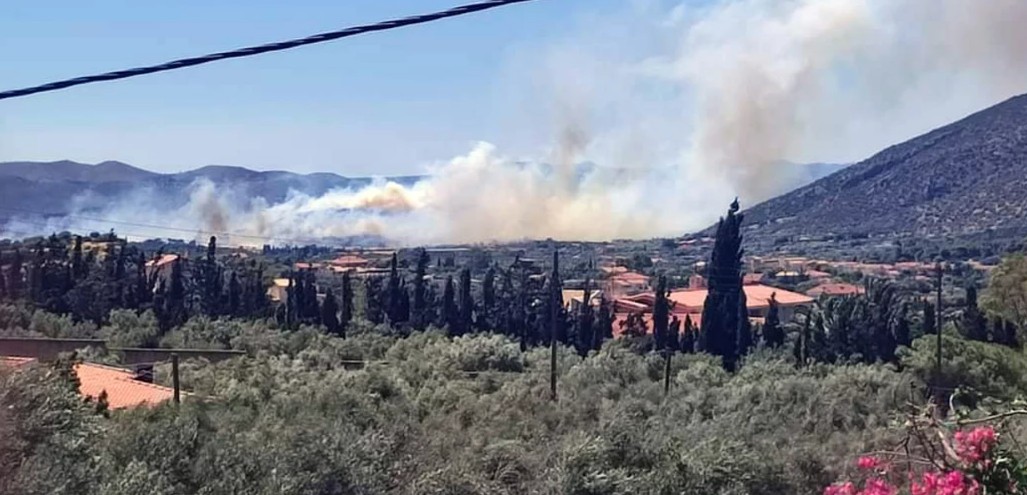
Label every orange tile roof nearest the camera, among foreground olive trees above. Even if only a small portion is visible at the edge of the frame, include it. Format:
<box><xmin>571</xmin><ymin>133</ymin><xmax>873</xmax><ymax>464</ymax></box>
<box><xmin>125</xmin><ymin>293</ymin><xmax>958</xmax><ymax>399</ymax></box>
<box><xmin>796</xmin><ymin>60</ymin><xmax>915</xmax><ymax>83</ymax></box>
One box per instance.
<box><xmin>0</xmin><ymin>356</ymin><xmax>175</xmax><ymax>409</ymax></box>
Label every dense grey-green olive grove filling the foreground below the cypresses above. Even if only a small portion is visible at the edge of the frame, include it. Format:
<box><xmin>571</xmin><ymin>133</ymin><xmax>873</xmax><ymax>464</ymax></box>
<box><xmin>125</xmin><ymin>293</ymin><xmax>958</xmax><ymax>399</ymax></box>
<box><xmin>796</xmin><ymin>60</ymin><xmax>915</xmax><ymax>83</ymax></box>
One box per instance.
<box><xmin>0</xmin><ymin>318</ymin><xmax>924</xmax><ymax>494</ymax></box>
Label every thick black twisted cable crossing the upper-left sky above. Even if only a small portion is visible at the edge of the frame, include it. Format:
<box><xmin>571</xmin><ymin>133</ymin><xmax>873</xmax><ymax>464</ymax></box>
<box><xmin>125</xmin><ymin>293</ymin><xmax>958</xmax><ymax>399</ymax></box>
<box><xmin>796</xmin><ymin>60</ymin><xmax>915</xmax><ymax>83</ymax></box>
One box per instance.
<box><xmin>0</xmin><ymin>0</ymin><xmax>534</xmax><ymax>100</ymax></box>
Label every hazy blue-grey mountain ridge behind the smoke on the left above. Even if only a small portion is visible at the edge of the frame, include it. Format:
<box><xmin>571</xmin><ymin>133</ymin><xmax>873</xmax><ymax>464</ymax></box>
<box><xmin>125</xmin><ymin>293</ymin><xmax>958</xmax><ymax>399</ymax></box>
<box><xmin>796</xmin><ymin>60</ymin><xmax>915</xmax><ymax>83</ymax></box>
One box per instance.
<box><xmin>0</xmin><ymin>160</ymin><xmax>422</xmax><ymax>224</ymax></box>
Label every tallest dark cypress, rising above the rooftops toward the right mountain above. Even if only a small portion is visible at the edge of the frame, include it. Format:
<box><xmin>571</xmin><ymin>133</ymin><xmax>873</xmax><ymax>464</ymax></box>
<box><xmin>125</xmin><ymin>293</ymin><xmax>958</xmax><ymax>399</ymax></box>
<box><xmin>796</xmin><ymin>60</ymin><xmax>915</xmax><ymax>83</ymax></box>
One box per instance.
<box><xmin>699</xmin><ymin>199</ymin><xmax>748</xmax><ymax>371</ymax></box>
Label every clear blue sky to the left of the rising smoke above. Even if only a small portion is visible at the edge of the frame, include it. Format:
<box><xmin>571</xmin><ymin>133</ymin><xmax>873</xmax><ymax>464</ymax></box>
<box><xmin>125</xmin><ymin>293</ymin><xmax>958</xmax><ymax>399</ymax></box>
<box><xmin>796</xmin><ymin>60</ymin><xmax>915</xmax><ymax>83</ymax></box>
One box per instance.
<box><xmin>0</xmin><ymin>0</ymin><xmax>627</xmax><ymax>176</ymax></box>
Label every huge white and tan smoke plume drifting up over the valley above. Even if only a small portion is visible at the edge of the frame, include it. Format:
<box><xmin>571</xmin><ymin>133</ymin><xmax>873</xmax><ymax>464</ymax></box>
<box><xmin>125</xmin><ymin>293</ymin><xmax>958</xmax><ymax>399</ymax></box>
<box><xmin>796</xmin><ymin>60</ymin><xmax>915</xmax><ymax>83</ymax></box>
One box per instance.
<box><xmin>2</xmin><ymin>0</ymin><xmax>1027</xmax><ymax>244</ymax></box>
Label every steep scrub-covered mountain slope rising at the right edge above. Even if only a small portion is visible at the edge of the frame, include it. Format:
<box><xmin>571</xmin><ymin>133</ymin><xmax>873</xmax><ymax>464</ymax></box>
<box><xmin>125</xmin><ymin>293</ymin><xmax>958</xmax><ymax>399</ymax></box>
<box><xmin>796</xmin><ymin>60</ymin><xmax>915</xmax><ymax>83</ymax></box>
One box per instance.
<box><xmin>746</xmin><ymin>94</ymin><xmax>1027</xmax><ymax>242</ymax></box>
